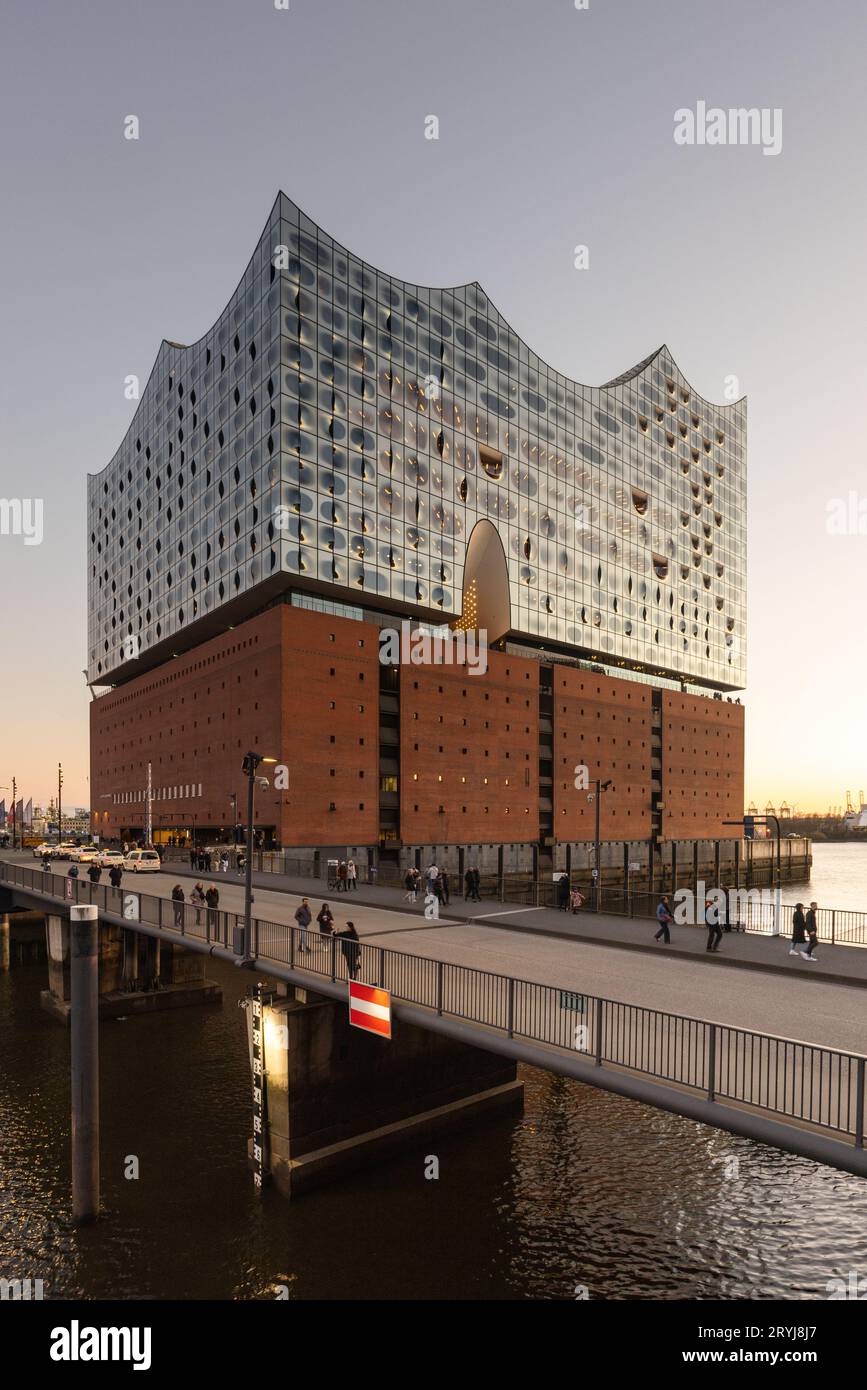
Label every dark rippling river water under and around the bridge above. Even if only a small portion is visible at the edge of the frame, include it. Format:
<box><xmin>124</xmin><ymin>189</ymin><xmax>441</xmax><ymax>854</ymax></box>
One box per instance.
<box><xmin>0</xmin><ymin>845</ymin><xmax>867</xmax><ymax>1300</ymax></box>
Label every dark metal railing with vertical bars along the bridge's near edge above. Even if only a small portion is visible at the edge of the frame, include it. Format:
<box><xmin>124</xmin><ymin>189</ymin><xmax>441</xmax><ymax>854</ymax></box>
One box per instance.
<box><xmin>0</xmin><ymin>862</ymin><xmax>867</xmax><ymax>1148</ymax></box>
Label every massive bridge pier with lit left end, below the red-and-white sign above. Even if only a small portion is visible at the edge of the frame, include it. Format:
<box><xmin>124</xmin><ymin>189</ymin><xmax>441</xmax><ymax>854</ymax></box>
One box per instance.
<box><xmin>246</xmin><ymin>988</ymin><xmax>524</xmax><ymax>1197</ymax></box>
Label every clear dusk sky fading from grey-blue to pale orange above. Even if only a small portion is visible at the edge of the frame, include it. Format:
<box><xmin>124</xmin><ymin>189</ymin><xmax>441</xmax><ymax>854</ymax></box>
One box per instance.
<box><xmin>0</xmin><ymin>0</ymin><xmax>867</xmax><ymax>810</ymax></box>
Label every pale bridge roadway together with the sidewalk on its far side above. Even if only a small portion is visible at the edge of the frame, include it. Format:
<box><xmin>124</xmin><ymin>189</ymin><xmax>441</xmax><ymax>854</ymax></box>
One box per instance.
<box><xmin>4</xmin><ymin>856</ymin><xmax>867</xmax><ymax>1052</ymax></box>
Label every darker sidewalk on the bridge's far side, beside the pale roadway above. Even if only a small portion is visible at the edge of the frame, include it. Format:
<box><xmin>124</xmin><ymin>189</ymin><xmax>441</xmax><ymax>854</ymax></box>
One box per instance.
<box><xmin>164</xmin><ymin>863</ymin><xmax>867</xmax><ymax>987</ymax></box>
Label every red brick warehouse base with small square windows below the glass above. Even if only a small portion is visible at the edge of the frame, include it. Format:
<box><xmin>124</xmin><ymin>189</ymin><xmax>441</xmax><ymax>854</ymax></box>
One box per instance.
<box><xmin>90</xmin><ymin>602</ymin><xmax>743</xmax><ymax>850</ymax></box>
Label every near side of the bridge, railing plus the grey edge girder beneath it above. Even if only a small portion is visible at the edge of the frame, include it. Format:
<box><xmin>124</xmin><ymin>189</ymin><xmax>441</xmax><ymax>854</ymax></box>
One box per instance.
<box><xmin>0</xmin><ymin>860</ymin><xmax>867</xmax><ymax>1176</ymax></box>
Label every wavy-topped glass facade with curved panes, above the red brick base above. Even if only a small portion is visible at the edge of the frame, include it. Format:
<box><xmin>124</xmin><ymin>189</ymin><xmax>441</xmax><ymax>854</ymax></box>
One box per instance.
<box><xmin>88</xmin><ymin>195</ymin><xmax>746</xmax><ymax>689</ymax></box>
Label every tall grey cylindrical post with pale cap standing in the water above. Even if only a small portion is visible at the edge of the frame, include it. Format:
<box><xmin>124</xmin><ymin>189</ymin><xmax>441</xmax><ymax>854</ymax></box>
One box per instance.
<box><xmin>69</xmin><ymin>905</ymin><xmax>99</xmax><ymax>1223</ymax></box>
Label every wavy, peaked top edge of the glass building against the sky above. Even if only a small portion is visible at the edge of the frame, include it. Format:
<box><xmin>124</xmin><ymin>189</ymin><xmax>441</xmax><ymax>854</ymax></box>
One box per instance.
<box><xmin>88</xmin><ymin>189</ymin><xmax>746</xmax><ymax>478</ymax></box>
